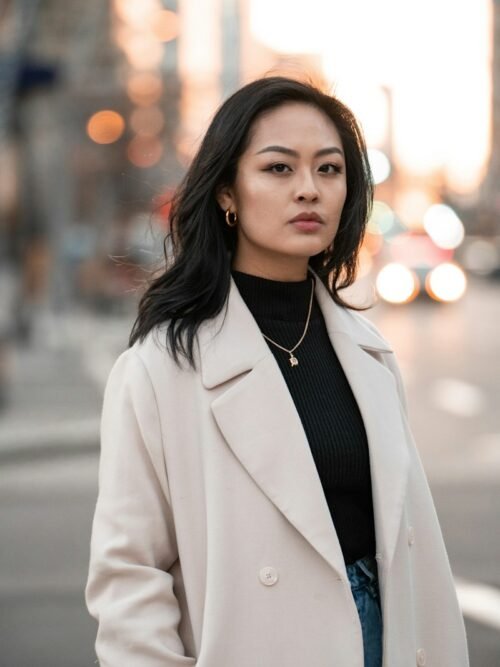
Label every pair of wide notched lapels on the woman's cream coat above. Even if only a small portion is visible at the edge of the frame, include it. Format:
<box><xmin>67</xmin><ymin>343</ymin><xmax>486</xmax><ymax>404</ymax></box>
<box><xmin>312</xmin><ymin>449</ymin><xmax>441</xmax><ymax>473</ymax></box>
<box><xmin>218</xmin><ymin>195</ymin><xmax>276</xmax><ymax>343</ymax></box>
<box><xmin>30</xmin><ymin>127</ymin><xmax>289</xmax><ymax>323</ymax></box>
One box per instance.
<box><xmin>198</xmin><ymin>280</ymin><xmax>407</xmax><ymax>579</ymax></box>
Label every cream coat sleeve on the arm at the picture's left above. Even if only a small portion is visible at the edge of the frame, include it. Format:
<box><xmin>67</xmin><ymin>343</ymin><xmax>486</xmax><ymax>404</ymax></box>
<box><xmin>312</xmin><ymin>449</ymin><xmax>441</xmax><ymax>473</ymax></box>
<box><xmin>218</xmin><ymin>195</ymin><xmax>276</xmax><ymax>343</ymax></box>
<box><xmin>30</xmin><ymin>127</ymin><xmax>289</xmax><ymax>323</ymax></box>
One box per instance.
<box><xmin>85</xmin><ymin>348</ymin><xmax>196</xmax><ymax>667</ymax></box>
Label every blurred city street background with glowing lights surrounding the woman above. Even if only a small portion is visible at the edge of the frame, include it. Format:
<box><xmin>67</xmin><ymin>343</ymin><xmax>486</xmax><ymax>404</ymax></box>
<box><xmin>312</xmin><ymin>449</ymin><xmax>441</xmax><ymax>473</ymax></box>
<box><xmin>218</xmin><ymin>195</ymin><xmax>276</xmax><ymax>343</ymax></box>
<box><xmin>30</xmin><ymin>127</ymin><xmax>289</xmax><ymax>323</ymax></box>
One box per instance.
<box><xmin>0</xmin><ymin>0</ymin><xmax>500</xmax><ymax>667</ymax></box>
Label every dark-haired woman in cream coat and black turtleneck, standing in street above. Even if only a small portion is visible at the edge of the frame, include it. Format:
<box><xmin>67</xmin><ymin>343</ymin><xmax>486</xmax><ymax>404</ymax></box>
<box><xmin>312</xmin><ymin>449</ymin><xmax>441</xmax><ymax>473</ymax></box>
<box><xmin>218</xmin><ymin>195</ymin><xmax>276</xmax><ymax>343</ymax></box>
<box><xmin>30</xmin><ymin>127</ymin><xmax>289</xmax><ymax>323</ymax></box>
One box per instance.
<box><xmin>86</xmin><ymin>77</ymin><xmax>468</xmax><ymax>667</ymax></box>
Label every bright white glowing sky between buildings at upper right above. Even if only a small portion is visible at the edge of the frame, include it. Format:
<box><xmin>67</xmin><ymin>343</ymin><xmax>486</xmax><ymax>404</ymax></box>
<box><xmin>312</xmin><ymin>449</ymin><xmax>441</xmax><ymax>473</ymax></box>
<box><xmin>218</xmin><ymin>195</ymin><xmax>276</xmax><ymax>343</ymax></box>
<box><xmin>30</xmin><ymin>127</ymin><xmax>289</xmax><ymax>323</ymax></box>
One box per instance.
<box><xmin>249</xmin><ymin>0</ymin><xmax>491</xmax><ymax>194</ymax></box>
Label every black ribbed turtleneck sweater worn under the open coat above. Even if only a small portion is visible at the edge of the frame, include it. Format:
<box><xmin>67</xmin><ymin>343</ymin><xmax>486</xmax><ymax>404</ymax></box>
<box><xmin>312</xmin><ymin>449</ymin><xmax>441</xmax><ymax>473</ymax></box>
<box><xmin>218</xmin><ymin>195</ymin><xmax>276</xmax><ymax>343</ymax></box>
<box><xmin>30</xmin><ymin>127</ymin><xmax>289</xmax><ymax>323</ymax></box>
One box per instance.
<box><xmin>233</xmin><ymin>271</ymin><xmax>375</xmax><ymax>564</ymax></box>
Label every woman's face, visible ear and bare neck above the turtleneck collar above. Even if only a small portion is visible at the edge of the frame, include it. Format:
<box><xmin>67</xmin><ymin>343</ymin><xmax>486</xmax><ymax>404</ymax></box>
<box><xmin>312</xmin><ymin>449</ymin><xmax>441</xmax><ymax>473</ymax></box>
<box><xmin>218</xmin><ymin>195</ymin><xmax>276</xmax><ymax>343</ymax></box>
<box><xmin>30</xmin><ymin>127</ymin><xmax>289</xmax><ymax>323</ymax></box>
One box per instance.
<box><xmin>218</xmin><ymin>102</ymin><xmax>347</xmax><ymax>280</ymax></box>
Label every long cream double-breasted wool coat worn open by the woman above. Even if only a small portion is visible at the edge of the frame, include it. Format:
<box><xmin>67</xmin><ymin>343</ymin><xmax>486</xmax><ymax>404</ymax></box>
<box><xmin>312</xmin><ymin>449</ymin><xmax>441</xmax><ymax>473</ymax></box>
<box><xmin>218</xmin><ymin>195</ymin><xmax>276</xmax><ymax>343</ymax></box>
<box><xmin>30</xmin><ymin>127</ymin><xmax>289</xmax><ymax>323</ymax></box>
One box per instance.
<box><xmin>86</xmin><ymin>280</ymin><xmax>468</xmax><ymax>667</ymax></box>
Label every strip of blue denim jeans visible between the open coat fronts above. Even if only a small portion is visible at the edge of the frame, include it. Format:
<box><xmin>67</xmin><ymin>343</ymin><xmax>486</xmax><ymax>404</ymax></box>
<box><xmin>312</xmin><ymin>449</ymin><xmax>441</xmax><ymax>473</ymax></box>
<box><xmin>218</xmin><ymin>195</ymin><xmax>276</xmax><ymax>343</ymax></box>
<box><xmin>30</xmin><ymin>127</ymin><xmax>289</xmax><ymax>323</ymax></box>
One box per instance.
<box><xmin>347</xmin><ymin>556</ymin><xmax>383</xmax><ymax>667</ymax></box>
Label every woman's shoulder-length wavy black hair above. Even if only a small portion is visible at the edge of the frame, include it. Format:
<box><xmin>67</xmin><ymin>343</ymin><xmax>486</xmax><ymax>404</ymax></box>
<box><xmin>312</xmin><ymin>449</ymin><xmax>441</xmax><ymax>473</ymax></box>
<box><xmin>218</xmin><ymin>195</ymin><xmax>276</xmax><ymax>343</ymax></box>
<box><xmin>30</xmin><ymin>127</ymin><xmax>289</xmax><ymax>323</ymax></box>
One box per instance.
<box><xmin>129</xmin><ymin>76</ymin><xmax>373</xmax><ymax>366</ymax></box>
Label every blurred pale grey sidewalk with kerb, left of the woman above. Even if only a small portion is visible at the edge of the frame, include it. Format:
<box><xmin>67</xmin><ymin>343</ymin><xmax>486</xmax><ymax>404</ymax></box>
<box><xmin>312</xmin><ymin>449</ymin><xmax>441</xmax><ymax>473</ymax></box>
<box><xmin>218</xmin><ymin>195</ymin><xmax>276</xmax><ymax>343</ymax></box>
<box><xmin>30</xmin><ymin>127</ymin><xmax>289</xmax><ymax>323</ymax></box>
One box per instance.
<box><xmin>0</xmin><ymin>311</ymin><xmax>131</xmax><ymax>462</ymax></box>
